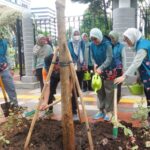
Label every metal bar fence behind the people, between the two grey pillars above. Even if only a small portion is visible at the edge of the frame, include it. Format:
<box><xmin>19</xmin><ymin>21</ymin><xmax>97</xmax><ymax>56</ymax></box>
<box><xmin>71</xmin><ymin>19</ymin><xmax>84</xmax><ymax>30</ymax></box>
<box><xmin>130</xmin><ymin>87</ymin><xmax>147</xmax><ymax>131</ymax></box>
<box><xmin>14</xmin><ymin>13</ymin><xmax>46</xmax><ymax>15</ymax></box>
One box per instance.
<box><xmin>34</xmin><ymin>14</ymin><xmax>112</xmax><ymax>41</ymax></box>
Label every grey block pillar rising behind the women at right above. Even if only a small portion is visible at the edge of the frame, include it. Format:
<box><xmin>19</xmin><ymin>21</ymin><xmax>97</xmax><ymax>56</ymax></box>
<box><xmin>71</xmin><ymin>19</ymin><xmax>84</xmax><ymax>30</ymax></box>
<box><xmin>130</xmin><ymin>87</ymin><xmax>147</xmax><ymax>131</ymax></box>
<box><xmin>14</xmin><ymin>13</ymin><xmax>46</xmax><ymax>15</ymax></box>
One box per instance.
<box><xmin>112</xmin><ymin>0</ymin><xmax>137</xmax><ymax>67</ymax></box>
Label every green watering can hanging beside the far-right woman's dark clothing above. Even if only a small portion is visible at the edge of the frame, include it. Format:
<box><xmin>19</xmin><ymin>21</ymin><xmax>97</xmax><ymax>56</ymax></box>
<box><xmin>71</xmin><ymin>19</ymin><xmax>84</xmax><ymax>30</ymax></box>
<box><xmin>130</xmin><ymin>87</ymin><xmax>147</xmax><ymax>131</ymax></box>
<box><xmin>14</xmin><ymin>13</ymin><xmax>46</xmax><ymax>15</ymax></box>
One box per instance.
<box><xmin>127</xmin><ymin>83</ymin><xmax>144</xmax><ymax>95</ymax></box>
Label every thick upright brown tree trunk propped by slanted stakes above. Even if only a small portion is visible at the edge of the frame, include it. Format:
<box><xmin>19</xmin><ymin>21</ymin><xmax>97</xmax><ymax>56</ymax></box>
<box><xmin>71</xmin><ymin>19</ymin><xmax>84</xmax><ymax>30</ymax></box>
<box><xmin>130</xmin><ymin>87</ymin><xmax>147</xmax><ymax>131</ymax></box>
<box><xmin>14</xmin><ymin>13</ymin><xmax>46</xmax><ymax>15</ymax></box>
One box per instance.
<box><xmin>56</xmin><ymin>0</ymin><xmax>75</xmax><ymax>150</ymax></box>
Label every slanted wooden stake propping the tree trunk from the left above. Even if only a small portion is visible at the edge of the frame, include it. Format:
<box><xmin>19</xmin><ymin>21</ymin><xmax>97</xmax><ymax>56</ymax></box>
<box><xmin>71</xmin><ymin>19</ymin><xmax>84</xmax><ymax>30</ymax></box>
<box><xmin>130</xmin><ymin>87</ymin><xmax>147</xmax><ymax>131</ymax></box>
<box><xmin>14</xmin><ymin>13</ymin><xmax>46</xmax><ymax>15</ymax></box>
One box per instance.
<box><xmin>24</xmin><ymin>48</ymin><xmax>58</xmax><ymax>150</ymax></box>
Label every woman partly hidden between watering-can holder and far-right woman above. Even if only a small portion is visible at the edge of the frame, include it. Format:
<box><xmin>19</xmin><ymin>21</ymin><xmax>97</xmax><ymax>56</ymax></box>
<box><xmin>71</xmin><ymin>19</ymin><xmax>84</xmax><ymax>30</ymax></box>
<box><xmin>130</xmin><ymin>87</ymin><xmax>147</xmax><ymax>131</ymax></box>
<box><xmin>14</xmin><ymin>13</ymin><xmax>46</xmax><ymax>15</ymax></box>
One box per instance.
<box><xmin>109</xmin><ymin>31</ymin><xmax>126</xmax><ymax>102</ymax></box>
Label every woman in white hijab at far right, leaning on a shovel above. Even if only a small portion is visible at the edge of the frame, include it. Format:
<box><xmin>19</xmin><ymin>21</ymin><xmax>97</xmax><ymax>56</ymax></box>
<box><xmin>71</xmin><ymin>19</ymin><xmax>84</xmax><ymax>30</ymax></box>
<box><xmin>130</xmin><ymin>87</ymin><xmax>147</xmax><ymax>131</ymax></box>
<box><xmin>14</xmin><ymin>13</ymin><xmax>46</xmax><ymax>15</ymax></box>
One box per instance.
<box><xmin>115</xmin><ymin>28</ymin><xmax>150</xmax><ymax>121</ymax></box>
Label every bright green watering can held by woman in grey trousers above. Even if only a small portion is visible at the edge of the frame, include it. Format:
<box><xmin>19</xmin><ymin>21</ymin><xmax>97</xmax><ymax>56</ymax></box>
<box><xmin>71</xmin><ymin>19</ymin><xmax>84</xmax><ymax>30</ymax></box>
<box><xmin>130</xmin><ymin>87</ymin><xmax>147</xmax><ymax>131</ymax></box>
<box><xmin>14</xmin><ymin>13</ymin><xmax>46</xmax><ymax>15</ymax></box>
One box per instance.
<box><xmin>91</xmin><ymin>73</ymin><xmax>102</xmax><ymax>92</ymax></box>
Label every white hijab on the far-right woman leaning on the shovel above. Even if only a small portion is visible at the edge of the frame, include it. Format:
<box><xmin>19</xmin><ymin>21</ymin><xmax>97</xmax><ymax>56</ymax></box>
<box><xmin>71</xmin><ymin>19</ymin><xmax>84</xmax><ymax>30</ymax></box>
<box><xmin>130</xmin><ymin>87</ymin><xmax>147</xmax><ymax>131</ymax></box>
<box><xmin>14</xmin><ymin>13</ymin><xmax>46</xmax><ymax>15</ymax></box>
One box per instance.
<box><xmin>123</xmin><ymin>28</ymin><xmax>142</xmax><ymax>45</ymax></box>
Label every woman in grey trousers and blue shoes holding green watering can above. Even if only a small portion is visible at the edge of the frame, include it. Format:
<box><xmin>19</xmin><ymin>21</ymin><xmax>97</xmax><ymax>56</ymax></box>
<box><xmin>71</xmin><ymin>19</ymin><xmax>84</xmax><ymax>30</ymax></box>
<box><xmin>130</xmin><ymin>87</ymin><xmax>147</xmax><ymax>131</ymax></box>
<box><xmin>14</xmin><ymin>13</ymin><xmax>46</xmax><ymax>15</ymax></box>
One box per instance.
<box><xmin>90</xmin><ymin>28</ymin><xmax>114</xmax><ymax>121</ymax></box>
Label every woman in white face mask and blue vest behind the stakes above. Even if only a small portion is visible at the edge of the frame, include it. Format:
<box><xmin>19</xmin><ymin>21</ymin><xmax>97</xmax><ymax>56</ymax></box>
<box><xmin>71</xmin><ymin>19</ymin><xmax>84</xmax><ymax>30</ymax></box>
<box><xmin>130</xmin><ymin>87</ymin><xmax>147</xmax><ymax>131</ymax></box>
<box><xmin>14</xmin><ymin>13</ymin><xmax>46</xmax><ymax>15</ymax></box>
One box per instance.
<box><xmin>68</xmin><ymin>29</ymin><xmax>87</xmax><ymax>120</ymax></box>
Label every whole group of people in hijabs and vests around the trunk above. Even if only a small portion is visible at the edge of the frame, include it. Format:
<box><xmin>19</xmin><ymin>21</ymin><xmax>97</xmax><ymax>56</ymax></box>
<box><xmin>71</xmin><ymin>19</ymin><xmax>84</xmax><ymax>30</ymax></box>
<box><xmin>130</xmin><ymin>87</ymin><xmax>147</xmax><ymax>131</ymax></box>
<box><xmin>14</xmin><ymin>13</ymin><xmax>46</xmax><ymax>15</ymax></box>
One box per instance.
<box><xmin>0</xmin><ymin>25</ymin><xmax>150</xmax><ymax>121</ymax></box>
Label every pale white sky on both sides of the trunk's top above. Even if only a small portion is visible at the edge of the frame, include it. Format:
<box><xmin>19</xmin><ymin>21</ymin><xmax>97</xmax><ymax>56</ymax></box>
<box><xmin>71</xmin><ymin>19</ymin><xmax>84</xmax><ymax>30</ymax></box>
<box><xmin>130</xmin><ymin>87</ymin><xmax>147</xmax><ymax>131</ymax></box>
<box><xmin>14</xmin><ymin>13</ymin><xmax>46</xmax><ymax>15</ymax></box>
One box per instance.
<box><xmin>31</xmin><ymin>0</ymin><xmax>88</xmax><ymax>16</ymax></box>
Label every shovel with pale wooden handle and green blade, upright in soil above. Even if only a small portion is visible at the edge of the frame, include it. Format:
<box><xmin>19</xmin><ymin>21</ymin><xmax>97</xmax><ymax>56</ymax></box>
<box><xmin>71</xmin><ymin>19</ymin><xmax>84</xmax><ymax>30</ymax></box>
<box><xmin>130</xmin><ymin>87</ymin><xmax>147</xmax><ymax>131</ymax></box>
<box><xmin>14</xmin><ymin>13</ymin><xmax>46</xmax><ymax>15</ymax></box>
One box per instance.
<box><xmin>113</xmin><ymin>84</ymin><xmax>118</xmax><ymax>139</ymax></box>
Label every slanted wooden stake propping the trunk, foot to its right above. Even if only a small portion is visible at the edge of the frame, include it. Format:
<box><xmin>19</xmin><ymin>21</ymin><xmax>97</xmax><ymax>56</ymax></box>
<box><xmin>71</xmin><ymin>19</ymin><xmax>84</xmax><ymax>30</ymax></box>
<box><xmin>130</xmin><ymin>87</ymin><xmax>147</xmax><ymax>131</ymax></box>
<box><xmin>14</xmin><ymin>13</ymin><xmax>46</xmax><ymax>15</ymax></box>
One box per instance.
<box><xmin>64</xmin><ymin>45</ymin><xmax>94</xmax><ymax>150</ymax></box>
